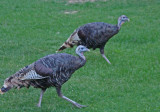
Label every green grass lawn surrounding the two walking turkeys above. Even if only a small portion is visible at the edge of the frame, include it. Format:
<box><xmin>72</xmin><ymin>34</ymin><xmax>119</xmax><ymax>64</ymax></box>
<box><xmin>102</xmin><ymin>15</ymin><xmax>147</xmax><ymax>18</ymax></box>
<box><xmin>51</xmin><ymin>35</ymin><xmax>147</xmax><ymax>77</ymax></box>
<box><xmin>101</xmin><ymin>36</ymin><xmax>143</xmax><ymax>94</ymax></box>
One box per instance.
<box><xmin>0</xmin><ymin>0</ymin><xmax>160</xmax><ymax>112</ymax></box>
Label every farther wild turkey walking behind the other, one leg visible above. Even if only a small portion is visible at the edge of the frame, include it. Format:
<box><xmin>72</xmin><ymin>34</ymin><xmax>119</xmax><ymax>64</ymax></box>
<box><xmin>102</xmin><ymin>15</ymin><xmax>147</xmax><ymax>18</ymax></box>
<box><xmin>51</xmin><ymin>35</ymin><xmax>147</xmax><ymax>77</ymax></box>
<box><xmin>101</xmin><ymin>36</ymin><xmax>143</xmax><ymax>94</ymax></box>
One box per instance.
<box><xmin>58</xmin><ymin>15</ymin><xmax>129</xmax><ymax>64</ymax></box>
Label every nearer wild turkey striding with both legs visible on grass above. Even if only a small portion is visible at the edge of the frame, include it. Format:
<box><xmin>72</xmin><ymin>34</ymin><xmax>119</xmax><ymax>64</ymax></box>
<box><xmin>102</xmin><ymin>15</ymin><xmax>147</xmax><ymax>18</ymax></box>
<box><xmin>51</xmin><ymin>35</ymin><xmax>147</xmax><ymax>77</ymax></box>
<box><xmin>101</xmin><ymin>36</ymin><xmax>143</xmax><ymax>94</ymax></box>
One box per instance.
<box><xmin>0</xmin><ymin>45</ymin><xmax>89</xmax><ymax>108</ymax></box>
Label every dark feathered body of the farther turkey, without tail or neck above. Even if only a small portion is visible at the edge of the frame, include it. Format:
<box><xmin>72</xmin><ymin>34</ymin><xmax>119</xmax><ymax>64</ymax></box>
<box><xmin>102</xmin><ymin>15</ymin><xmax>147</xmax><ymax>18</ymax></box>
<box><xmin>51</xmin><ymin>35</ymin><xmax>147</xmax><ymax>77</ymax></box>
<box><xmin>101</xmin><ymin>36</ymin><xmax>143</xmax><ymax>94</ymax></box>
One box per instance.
<box><xmin>76</xmin><ymin>22</ymin><xmax>119</xmax><ymax>49</ymax></box>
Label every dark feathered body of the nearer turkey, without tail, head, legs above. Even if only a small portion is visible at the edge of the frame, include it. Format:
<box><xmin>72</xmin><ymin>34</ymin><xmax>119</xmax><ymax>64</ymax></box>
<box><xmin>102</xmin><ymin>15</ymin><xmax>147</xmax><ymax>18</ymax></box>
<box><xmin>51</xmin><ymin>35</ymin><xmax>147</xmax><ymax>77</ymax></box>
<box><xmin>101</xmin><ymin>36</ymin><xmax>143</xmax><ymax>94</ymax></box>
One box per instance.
<box><xmin>17</xmin><ymin>53</ymin><xmax>86</xmax><ymax>89</ymax></box>
